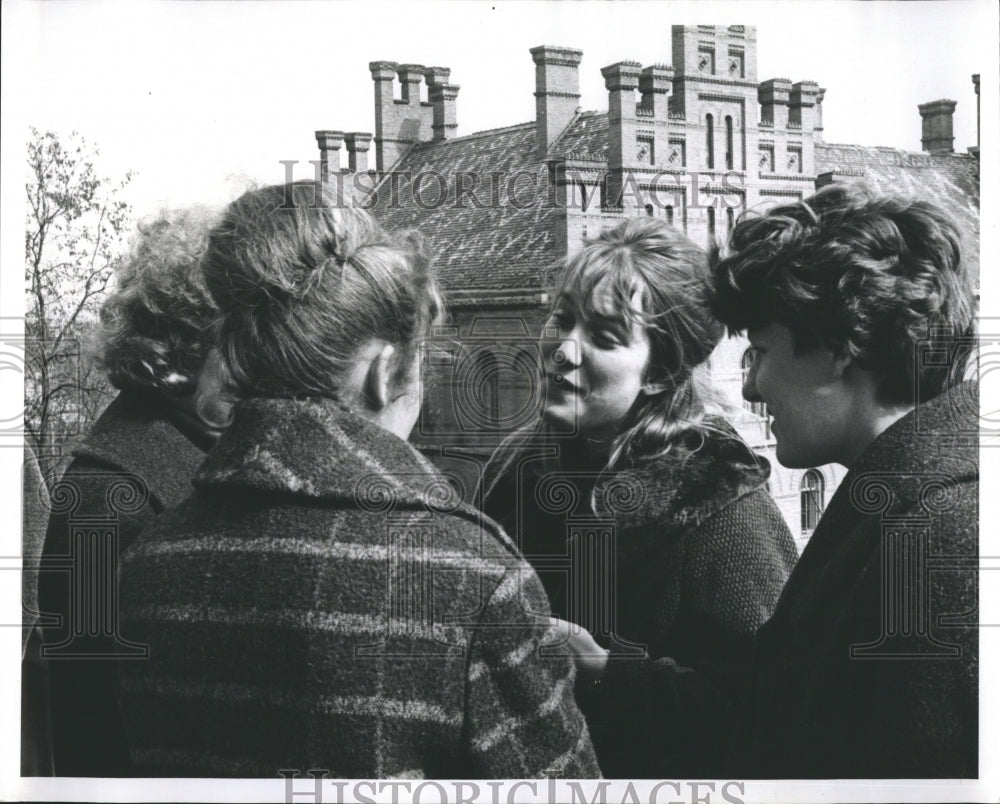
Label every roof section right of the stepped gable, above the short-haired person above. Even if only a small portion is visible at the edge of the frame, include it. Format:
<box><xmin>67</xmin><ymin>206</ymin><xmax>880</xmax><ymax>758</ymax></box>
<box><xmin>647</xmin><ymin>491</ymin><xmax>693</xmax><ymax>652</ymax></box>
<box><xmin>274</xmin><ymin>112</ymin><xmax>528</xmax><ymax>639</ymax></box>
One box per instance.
<box><xmin>816</xmin><ymin>143</ymin><xmax>979</xmax><ymax>286</ymax></box>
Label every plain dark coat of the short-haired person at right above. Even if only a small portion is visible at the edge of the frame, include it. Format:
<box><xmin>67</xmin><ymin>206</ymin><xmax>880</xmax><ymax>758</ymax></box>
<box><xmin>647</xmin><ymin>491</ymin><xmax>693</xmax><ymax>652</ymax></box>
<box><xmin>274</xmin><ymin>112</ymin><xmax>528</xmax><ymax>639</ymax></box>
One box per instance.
<box><xmin>589</xmin><ymin>384</ymin><xmax>979</xmax><ymax>778</ymax></box>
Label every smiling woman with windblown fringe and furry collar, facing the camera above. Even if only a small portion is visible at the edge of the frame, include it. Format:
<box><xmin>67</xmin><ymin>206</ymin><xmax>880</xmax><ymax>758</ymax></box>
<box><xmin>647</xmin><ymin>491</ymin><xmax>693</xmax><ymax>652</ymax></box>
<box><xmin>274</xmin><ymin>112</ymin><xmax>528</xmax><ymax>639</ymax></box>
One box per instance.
<box><xmin>482</xmin><ymin>218</ymin><xmax>796</xmax><ymax>777</ymax></box>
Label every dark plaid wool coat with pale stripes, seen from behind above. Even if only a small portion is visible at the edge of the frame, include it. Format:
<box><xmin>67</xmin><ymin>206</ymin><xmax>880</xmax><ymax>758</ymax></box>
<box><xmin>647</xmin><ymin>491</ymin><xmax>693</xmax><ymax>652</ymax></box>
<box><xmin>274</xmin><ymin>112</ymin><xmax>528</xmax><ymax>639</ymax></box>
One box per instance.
<box><xmin>121</xmin><ymin>399</ymin><xmax>599</xmax><ymax>778</ymax></box>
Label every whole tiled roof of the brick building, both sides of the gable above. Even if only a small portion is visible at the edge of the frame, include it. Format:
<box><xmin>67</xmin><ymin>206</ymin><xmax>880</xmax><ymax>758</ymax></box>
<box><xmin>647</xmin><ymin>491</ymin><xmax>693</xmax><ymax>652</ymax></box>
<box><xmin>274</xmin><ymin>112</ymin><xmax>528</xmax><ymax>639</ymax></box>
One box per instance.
<box><xmin>373</xmin><ymin>112</ymin><xmax>979</xmax><ymax>298</ymax></box>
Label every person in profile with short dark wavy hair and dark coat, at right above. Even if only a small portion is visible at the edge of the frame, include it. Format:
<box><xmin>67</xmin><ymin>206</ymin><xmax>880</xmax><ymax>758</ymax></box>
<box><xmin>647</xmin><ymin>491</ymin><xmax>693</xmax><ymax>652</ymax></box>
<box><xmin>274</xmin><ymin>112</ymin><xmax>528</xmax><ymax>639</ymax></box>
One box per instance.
<box><xmin>560</xmin><ymin>184</ymin><xmax>979</xmax><ymax>779</ymax></box>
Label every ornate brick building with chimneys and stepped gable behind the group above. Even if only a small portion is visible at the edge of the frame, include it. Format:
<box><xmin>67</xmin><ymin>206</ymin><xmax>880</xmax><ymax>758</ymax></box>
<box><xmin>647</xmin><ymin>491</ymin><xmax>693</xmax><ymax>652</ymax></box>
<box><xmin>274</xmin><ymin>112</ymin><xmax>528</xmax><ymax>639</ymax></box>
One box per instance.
<box><xmin>316</xmin><ymin>25</ymin><xmax>979</xmax><ymax>544</ymax></box>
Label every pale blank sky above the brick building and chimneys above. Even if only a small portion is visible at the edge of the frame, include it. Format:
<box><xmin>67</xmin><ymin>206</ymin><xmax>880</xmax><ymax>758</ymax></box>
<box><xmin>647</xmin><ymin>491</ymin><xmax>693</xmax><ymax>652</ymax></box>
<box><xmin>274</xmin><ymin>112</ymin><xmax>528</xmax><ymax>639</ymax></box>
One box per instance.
<box><xmin>3</xmin><ymin>0</ymin><xmax>1000</xmax><ymax>216</ymax></box>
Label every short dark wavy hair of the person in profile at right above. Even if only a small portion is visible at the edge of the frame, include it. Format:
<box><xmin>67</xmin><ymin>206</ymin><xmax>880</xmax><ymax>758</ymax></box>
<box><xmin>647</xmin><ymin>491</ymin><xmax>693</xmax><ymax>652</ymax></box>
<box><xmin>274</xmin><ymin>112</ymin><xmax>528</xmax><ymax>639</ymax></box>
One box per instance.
<box><xmin>711</xmin><ymin>183</ymin><xmax>976</xmax><ymax>404</ymax></box>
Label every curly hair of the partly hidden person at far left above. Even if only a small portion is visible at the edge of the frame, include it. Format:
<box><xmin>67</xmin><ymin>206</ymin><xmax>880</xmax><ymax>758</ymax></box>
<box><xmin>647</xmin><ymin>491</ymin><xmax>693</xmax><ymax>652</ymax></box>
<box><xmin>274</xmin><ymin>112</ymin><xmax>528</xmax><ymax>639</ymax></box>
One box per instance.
<box><xmin>94</xmin><ymin>206</ymin><xmax>218</xmax><ymax>396</ymax></box>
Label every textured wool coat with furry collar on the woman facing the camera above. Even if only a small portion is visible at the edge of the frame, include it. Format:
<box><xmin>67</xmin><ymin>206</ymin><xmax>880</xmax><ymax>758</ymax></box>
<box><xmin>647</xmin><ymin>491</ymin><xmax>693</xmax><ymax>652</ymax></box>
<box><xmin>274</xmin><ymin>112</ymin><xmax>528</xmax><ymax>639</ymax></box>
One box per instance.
<box><xmin>483</xmin><ymin>419</ymin><xmax>797</xmax><ymax>778</ymax></box>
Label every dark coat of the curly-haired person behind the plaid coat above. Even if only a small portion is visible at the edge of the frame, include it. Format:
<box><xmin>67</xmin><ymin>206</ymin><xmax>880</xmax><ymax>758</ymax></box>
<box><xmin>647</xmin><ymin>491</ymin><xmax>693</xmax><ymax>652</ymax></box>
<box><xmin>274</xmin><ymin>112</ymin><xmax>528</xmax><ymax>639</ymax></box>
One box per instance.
<box><xmin>38</xmin><ymin>390</ymin><xmax>212</xmax><ymax>776</ymax></box>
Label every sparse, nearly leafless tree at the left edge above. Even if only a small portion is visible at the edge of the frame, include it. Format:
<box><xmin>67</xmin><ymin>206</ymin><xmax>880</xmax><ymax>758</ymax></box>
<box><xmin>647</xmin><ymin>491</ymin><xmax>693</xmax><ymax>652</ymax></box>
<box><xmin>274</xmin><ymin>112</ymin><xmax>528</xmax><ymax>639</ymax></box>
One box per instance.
<box><xmin>24</xmin><ymin>128</ymin><xmax>132</xmax><ymax>480</ymax></box>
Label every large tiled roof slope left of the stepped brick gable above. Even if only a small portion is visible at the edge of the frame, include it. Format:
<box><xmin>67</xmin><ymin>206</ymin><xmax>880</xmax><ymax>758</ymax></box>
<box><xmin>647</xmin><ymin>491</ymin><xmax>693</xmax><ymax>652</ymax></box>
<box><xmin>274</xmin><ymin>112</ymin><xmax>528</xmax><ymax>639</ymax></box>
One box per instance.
<box><xmin>372</xmin><ymin>122</ymin><xmax>561</xmax><ymax>291</ymax></box>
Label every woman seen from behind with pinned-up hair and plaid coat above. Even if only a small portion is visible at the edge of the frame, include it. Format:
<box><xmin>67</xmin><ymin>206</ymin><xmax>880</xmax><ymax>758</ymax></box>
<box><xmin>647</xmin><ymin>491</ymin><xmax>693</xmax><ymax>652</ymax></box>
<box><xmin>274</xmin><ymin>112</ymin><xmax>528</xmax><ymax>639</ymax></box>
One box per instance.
<box><xmin>113</xmin><ymin>182</ymin><xmax>597</xmax><ymax>779</ymax></box>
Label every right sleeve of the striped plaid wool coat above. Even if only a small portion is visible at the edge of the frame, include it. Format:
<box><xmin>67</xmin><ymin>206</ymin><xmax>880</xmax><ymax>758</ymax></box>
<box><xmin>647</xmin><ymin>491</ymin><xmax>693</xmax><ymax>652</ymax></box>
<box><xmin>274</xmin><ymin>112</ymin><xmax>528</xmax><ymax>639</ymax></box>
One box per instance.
<box><xmin>464</xmin><ymin>562</ymin><xmax>600</xmax><ymax>779</ymax></box>
